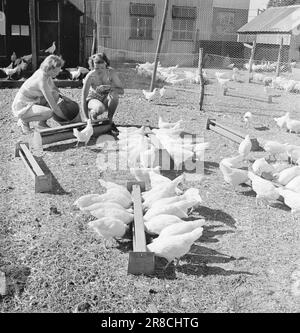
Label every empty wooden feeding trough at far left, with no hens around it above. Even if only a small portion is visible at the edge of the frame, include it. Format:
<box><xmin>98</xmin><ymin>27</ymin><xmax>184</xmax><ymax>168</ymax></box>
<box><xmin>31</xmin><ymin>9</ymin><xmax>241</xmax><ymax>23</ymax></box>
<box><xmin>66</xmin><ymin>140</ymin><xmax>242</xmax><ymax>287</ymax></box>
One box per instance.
<box><xmin>15</xmin><ymin>142</ymin><xmax>52</xmax><ymax>193</ymax></box>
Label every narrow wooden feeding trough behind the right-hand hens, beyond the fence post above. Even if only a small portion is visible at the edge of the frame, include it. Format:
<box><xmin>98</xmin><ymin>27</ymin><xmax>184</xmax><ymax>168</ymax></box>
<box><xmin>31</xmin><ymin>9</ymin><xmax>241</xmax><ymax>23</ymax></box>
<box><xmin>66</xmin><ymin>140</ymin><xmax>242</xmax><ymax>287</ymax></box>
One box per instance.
<box><xmin>206</xmin><ymin>118</ymin><xmax>263</xmax><ymax>151</ymax></box>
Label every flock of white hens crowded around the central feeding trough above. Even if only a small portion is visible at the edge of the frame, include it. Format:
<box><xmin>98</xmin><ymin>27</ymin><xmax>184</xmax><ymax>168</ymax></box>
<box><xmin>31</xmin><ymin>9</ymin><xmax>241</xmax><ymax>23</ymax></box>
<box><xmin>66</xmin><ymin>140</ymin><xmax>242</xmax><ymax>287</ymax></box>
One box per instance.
<box><xmin>74</xmin><ymin>116</ymin><xmax>208</xmax><ymax>264</ymax></box>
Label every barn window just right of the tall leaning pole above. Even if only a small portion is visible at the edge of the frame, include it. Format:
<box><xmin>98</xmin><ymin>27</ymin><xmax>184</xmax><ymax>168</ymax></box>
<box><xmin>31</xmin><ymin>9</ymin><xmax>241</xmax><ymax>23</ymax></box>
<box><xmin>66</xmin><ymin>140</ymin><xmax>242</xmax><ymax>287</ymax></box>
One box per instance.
<box><xmin>172</xmin><ymin>6</ymin><xmax>197</xmax><ymax>40</ymax></box>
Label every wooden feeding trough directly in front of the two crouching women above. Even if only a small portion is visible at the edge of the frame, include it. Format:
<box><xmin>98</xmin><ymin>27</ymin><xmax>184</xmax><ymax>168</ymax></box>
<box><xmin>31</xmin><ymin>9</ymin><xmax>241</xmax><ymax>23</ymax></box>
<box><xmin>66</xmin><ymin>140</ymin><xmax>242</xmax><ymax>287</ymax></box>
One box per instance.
<box><xmin>37</xmin><ymin>121</ymin><xmax>112</xmax><ymax>145</ymax></box>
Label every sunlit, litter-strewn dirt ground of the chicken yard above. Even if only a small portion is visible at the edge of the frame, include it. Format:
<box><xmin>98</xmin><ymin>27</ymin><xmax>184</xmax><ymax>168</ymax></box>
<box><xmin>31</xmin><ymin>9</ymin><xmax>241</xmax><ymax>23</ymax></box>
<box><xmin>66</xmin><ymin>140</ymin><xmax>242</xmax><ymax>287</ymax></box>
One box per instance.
<box><xmin>0</xmin><ymin>70</ymin><xmax>300</xmax><ymax>313</ymax></box>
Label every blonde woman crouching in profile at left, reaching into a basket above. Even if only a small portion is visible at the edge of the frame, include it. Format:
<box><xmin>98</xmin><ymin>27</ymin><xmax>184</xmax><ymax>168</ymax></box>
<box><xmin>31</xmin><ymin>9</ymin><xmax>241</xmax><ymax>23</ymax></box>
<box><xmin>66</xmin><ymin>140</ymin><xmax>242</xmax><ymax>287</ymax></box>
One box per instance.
<box><xmin>12</xmin><ymin>55</ymin><xmax>74</xmax><ymax>134</ymax></box>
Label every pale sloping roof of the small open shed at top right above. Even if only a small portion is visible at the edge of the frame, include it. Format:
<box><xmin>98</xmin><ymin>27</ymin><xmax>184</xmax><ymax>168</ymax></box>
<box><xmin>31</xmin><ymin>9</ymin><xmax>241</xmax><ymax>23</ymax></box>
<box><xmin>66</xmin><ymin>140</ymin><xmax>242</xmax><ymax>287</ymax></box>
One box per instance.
<box><xmin>238</xmin><ymin>5</ymin><xmax>300</xmax><ymax>34</ymax></box>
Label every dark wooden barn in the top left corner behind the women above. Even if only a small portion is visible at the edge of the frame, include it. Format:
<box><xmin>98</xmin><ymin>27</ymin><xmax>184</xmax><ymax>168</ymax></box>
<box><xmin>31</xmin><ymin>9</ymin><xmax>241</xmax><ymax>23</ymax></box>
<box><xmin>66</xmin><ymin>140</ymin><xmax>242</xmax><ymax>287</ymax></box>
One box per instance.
<box><xmin>0</xmin><ymin>0</ymin><xmax>84</xmax><ymax>67</ymax></box>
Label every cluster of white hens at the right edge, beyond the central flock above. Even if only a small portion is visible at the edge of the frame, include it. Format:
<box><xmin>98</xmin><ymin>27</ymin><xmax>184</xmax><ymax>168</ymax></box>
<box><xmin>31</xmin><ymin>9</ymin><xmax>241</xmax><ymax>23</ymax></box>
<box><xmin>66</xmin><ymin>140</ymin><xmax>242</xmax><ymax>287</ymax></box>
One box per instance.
<box><xmin>220</xmin><ymin>130</ymin><xmax>300</xmax><ymax>218</ymax></box>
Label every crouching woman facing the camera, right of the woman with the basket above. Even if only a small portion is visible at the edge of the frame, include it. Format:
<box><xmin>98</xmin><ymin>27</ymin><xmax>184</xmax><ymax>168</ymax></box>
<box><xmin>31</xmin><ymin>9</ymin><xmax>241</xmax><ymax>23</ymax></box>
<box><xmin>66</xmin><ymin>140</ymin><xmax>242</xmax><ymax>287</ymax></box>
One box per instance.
<box><xmin>81</xmin><ymin>53</ymin><xmax>124</xmax><ymax>123</ymax></box>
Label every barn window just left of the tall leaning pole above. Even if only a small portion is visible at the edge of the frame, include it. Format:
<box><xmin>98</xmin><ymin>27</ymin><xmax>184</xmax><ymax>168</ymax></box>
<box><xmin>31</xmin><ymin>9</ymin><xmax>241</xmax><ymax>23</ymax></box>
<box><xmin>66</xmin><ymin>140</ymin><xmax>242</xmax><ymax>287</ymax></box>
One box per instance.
<box><xmin>129</xmin><ymin>3</ymin><xmax>155</xmax><ymax>39</ymax></box>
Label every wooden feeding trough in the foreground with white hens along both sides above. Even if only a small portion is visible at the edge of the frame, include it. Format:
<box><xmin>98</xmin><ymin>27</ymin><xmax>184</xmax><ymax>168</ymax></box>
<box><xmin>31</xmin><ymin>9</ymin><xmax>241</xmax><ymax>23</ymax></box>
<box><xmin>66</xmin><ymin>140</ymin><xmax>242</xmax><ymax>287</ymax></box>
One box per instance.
<box><xmin>127</xmin><ymin>182</ymin><xmax>155</xmax><ymax>275</ymax></box>
